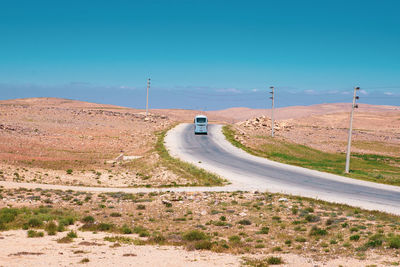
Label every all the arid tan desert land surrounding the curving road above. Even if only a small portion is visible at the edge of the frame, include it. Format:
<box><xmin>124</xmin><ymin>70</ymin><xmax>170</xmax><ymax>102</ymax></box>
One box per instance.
<box><xmin>0</xmin><ymin>98</ymin><xmax>400</xmax><ymax>266</ymax></box>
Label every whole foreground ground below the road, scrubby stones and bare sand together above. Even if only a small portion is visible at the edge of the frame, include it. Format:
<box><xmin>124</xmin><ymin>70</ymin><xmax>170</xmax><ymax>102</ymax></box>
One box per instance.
<box><xmin>0</xmin><ymin>189</ymin><xmax>400</xmax><ymax>266</ymax></box>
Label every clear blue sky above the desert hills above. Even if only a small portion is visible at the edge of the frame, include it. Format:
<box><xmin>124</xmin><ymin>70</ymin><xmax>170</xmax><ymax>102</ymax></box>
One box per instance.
<box><xmin>0</xmin><ymin>0</ymin><xmax>400</xmax><ymax>109</ymax></box>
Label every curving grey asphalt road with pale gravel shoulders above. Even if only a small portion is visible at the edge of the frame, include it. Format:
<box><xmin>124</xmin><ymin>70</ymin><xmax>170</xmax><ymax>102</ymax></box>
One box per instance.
<box><xmin>165</xmin><ymin>124</ymin><xmax>400</xmax><ymax>215</ymax></box>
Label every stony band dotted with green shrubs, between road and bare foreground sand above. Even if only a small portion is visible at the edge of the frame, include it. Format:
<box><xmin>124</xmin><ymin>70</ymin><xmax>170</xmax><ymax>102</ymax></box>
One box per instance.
<box><xmin>0</xmin><ymin>189</ymin><xmax>400</xmax><ymax>266</ymax></box>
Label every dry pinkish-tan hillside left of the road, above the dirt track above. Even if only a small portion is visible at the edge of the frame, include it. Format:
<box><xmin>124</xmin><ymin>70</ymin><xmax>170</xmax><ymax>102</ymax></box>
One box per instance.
<box><xmin>0</xmin><ymin>98</ymin><xmax>195</xmax><ymax>187</ymax></box>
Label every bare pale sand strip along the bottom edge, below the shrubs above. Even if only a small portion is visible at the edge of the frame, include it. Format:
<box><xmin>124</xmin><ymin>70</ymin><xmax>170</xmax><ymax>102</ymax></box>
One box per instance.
<box><xmin>0</xmin><ymin>230</ymin><xmax>399</xmax><ymax>267</ymax></box>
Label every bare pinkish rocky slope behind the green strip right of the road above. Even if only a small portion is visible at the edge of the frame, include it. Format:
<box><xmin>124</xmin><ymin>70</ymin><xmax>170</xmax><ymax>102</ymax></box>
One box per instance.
<box><xmin>235</xmin><ymin>109</ymin><xmax>400</xmax><ymax>157</ymax></box>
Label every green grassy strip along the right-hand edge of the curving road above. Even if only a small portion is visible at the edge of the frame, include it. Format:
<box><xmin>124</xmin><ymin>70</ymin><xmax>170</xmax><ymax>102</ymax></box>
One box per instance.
<box><xmin>223</xmin><ymin>125</ymin><xmax>400</xmax><ymax>185</ymax></box>
